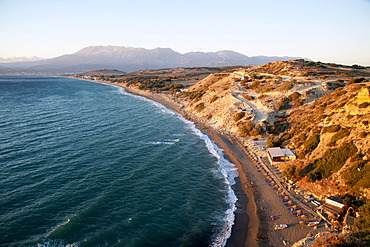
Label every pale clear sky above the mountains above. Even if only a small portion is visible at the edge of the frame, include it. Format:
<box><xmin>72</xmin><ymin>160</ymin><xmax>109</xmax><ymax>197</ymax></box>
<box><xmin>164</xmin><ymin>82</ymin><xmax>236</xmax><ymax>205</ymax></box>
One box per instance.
<box><xmin>0</xmin><ymin>0</ymin><xmax>370</xmax><ymax>65</ymax></box>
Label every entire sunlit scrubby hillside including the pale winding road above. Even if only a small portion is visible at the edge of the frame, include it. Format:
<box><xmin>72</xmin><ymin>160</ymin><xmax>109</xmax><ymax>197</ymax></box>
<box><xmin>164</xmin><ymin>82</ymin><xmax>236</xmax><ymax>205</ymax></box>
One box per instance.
<box><xmin>178</xmin><ymin>60</ymin><xmax>370</xmax><ymax>197</ymax></box>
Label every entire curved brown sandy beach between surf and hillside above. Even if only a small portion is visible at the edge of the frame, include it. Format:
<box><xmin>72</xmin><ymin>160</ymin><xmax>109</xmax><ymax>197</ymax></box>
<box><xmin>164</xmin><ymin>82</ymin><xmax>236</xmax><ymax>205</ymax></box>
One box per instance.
<box><xmin>97</xmin><ymin>82</ymin><xmax>323</xmax><ymax>247</ymax></box>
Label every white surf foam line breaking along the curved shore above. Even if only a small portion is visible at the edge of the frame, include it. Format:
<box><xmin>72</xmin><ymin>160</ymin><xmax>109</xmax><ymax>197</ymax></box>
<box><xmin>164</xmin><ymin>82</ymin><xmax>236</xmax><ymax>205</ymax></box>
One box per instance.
<box><xmin>112</xmin><ymin>85</ymin><xmax>238</xmax><ymax>247</ymax></box>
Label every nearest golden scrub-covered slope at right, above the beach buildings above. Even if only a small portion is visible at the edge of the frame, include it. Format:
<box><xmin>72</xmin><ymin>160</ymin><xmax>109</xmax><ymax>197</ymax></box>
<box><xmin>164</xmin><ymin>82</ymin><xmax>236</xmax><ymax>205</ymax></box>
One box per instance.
<box><xmin>279</xmin><ymin>81</ymin><xmax>370</xmax><ymax>197</ymax></box>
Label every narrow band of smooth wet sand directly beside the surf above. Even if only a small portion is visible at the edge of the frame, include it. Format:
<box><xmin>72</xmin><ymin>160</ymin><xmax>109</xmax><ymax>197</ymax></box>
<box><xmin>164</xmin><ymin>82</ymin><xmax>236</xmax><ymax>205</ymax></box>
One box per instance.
<box><xmin>101</xmin><ymin>82</ymin><xmax>260</xmax><ymax>247</ymax></box>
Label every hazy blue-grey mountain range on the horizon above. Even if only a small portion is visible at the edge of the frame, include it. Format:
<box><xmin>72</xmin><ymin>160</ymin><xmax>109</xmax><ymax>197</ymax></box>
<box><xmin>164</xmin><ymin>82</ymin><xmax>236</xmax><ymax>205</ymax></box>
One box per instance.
<box><xmin>0</xmin><ymin>46</ymin><xmax>299</xmax><ymax>74</ymax></box>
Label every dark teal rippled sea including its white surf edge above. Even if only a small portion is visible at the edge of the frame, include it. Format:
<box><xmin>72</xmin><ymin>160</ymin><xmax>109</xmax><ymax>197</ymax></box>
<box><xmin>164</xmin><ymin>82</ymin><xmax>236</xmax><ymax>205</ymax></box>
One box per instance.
<box><xmin>0</xmin><ymin>76</ymin><xmax>237</xmax><ymax>247</ymax></box>
